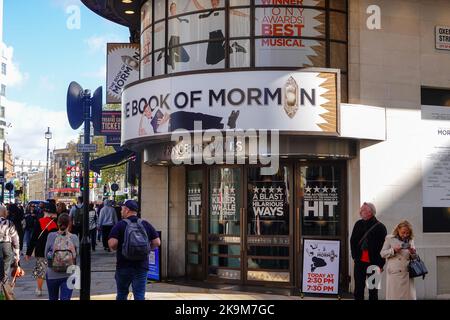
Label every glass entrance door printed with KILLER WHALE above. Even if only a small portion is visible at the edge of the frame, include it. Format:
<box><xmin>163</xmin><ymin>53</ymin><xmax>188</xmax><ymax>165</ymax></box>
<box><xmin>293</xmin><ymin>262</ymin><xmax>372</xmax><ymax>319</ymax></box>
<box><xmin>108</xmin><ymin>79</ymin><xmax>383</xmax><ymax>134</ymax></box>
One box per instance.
<box><xmin>207</xmin><ymin>167</ymin><xmax>242</xmax><ymax>281</ymax></box>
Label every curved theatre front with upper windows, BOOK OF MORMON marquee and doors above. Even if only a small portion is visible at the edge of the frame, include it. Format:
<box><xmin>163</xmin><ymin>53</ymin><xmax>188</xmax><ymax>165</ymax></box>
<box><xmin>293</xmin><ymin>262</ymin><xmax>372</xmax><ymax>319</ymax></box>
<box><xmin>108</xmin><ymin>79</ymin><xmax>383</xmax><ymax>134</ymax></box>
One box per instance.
<box><xmin>118</xmin><ymin>1</ymin><xmax>372</xmax><ymax>294</ymax></box>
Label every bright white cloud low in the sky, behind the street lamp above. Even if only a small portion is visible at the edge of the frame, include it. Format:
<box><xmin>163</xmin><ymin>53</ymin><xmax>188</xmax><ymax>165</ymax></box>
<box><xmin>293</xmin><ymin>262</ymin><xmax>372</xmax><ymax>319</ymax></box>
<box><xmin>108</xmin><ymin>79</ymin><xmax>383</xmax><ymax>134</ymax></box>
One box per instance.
<box><xmin>6</xmin><ymin>101</ymin><xmax>79</xmax><ymax>160</ymax></box>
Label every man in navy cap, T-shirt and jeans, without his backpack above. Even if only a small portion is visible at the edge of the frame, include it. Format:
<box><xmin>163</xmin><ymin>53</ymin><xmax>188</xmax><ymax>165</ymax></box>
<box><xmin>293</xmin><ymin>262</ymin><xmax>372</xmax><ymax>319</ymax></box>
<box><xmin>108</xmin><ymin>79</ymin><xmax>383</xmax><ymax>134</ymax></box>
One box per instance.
<box><xmin>108</xmin><ymin>200</ymin><xmax>161</xmax><ymax>300</ymax></box>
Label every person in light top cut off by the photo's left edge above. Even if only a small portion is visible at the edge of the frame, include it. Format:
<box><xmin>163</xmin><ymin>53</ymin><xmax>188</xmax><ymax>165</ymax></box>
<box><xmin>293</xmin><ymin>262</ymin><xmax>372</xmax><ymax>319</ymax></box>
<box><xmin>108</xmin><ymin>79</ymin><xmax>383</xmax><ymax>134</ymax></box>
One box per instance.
<box><xmin>0</xmin><ymin>205</ymin><xmax>20</xmax><ymax>283</ymax></box>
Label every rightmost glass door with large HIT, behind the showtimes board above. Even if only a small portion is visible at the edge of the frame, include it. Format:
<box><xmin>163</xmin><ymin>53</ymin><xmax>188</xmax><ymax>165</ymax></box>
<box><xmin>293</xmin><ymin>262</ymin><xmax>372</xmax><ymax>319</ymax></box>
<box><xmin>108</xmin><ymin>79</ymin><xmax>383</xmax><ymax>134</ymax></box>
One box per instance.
<box><xmin>296</xmin><ymin>161</ymin><xmax>348</xmax><ymax>288</ymax></box>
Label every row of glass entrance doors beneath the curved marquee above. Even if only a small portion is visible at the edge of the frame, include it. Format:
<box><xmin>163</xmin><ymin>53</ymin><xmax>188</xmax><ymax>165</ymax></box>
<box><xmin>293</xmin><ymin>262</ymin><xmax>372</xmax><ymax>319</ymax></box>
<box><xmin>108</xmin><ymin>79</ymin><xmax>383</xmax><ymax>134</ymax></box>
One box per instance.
<box><xmin>186</xmin><ymin>161</ymin><xmax>348</xmax><ymax>288</ymax></box>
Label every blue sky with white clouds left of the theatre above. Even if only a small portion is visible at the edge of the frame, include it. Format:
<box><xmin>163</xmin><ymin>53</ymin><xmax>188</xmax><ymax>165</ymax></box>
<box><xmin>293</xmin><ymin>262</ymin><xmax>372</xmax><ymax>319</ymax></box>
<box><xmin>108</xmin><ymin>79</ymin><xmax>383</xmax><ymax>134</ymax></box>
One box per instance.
<box><xmin>3</xmin><ymin>0</ymin><xmax>129</xmax><ymax>160</ymax></box>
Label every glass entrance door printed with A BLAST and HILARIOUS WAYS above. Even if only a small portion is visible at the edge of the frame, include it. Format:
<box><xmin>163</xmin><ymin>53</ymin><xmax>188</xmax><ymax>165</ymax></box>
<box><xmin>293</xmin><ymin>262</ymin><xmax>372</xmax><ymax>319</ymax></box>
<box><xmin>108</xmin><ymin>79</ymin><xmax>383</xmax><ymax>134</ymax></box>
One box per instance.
<box><xmin>246</xmin><ymin>165</ymin><xmax>293</xmax><ymax>284</ymax></box>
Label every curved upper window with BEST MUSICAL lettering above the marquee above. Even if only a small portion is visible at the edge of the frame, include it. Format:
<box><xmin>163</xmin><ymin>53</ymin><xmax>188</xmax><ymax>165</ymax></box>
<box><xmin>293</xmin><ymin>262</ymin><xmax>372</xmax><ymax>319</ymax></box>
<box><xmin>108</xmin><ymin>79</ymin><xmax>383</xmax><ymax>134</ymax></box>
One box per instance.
<box><xmin>141</xmin><ymin>0</ymin><xmax>348</xmax><ymax>102</ymax></box>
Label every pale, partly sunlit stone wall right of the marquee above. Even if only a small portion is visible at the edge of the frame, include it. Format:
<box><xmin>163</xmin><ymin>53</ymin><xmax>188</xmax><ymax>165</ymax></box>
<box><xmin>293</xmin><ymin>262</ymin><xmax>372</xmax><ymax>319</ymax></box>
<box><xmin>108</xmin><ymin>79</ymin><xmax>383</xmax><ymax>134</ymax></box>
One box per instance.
<box><xmin>349</xmin><ymin>0</ymin><xmax>450</xmax><ymax>299</ymax></box>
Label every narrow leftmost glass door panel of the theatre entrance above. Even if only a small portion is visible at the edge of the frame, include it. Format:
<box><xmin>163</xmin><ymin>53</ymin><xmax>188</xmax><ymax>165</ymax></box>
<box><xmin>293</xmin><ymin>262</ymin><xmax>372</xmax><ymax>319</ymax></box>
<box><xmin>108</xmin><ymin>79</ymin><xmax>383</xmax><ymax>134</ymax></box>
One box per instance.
<box><xmin>186</xmin><ymin>169</ymin><xmax>204</xmax><ymax>280</ymax></box>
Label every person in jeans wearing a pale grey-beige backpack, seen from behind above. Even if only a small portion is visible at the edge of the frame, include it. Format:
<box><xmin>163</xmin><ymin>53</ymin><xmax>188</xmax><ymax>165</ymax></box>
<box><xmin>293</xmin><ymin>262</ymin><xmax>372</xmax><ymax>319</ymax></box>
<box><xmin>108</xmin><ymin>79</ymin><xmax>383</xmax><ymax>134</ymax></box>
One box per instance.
<box><xmin>44</xmin><ymin>213</ymin><xmax>80</xmax><ymax>300</ymax></box>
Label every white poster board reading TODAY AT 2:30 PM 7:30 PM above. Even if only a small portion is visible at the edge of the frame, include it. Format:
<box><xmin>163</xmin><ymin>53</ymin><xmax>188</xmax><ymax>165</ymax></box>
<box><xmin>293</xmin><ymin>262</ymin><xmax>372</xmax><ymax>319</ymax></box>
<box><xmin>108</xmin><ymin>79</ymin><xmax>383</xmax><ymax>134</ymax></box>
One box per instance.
<box><xmin>302</xmin><ymin>239</ymin><xmax>340</xmax><ymax>294</ymax></box>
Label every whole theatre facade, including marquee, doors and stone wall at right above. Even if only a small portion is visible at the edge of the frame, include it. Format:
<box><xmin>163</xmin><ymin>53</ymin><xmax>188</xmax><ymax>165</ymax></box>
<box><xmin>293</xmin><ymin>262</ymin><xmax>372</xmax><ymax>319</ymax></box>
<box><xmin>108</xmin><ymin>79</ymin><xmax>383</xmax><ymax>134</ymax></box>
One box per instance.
<box><xmin>83</xmin><ymin>0</ymin><xmax>450</xmax><ymax>298</ymax></box>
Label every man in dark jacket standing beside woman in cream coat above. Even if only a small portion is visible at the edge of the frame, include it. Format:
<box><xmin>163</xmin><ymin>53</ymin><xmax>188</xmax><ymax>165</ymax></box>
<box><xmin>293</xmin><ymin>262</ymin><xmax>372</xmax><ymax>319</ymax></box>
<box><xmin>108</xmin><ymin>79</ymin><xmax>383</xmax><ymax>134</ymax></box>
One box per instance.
<box><xmin>350</xmin><ymin>202</ymin><xmax>387</xmax><ymax>300</ymax></box>
